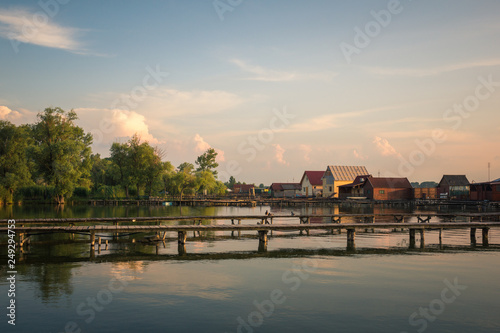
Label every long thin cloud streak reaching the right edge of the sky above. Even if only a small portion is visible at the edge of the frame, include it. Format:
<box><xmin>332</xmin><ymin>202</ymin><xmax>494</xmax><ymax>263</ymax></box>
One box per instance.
<box><xmin>364</xmin><ymin>59</ymin><xmax>500</xmax><ymax>77</ymax></box>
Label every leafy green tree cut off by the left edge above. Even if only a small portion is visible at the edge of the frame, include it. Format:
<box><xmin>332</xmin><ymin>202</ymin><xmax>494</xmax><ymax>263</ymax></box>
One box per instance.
<box><xmin>0</xmin><ymin>120</ymin><xmax>32</xmax><ymax>201</ymax></box>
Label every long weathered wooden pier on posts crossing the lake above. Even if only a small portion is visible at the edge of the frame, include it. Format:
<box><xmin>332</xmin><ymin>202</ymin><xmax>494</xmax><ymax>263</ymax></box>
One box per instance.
<box><xmin>0</xmin><ymin>213</ymin><xmax>500</xmax><ymax>256</ymax></box>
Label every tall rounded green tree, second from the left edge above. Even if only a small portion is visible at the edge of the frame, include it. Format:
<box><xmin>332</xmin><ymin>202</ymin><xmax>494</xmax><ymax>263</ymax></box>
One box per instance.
<box><xmin>29</xmin><ymin>107</ymin><xmax>92</xmax><ymax>203</ymax></box>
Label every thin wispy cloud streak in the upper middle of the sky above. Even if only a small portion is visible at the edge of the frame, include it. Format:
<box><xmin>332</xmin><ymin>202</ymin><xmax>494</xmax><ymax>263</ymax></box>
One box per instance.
<box><xmin>230</xmin><ymin>59</ymin><xmax>337</xmax><ymax>82</ymax></box>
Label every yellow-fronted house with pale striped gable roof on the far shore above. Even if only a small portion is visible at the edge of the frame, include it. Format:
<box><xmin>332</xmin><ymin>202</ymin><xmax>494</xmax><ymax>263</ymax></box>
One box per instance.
<box><xmin>322</xmin><ymin>165</ymin><xmax>369</xmax><ymax>198</ymax></box>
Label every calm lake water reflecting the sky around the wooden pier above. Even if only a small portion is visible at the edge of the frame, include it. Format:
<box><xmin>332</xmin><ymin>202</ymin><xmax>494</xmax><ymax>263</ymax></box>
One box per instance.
<box><xmin>0</xmin><ymin>207</ymin><xmax>500</xmax><ymax>332</ymax></box>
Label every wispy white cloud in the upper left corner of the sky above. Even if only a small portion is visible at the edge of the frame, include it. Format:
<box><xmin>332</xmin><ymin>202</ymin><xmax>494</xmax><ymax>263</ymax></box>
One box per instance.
<box><xmin>0</xmin><ymin>9</ymin><xmax>86</xmax><ymax>53</ymax></box>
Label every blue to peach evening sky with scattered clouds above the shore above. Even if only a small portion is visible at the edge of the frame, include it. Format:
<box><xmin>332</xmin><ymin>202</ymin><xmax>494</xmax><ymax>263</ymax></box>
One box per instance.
<box><xmin>0</xmin><ymin>0</ymin><xmax>500</xmax><ymax>185</ymax></box>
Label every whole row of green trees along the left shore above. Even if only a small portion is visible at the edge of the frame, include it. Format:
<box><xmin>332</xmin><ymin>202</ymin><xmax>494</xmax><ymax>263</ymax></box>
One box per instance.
<box><xmin>0</xmin><ymin>108</ymin><xmax>226</xmax><ymax>203</ymax></box>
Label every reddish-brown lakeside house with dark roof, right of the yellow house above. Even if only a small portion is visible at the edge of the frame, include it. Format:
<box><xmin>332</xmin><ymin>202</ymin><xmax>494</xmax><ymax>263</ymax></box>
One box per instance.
<box><xmin>363</xmin><ymin>177</ymin><xmax>413</xmax><ymax>200</ymax></box>
